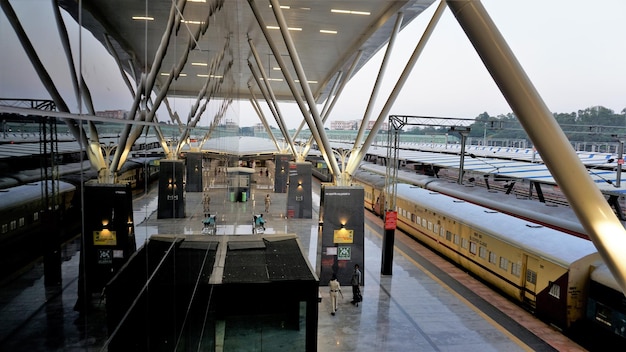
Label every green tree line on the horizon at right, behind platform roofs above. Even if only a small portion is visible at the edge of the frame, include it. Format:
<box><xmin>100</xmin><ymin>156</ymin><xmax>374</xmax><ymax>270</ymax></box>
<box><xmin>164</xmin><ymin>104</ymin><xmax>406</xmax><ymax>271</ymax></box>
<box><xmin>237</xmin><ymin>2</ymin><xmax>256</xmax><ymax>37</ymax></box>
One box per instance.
<box><xmin>405</xmin><ymin>106</ymin><xmax>626</xmax><ymax>142</ymax></box>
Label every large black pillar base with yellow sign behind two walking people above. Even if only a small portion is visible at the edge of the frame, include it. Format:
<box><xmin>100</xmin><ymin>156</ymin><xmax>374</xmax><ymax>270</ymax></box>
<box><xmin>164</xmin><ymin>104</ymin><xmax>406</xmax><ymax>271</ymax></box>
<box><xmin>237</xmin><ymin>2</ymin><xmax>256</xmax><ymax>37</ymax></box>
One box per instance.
<box><xmin>319</xmin><ymin>186</ymin><xmax>365</xmax><ymax>287</ymax></box>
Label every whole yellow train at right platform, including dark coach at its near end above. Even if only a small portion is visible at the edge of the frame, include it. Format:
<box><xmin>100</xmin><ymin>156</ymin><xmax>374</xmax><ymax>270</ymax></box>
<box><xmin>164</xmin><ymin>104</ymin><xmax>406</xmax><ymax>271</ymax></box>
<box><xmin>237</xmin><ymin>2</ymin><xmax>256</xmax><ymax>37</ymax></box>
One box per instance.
<box><xmin>353</xmin><ymin>170</ymin><xmax>626</xmax><ymax>343</ymax></box>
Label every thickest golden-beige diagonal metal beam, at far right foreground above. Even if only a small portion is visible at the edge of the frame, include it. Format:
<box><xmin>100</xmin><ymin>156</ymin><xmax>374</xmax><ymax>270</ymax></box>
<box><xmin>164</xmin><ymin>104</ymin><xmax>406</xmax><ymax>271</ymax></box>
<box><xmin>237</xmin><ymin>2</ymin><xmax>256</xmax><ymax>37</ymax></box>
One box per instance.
<box><xmin>448</xmin><ymin>0</ymin><xmax>626</xmax><ymax>292</ymax></box>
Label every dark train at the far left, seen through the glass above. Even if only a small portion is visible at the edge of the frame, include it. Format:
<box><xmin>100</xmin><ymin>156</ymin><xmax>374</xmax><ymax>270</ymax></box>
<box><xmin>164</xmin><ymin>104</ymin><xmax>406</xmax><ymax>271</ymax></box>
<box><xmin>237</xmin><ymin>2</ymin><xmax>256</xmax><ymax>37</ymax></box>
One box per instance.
<box><xmin>0</xmin><ymin>158</ymin><xmax>160</xmax><ymax>281</ymax></box>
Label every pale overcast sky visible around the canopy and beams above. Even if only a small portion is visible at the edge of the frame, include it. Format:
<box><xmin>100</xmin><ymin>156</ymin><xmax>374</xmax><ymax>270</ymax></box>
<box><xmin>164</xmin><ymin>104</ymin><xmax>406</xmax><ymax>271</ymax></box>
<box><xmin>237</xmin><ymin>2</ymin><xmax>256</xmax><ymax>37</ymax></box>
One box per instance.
<box><xmin>0</xmin><ymin>0</ymin><xmax>626</xmax><ymax>128</ymax></box>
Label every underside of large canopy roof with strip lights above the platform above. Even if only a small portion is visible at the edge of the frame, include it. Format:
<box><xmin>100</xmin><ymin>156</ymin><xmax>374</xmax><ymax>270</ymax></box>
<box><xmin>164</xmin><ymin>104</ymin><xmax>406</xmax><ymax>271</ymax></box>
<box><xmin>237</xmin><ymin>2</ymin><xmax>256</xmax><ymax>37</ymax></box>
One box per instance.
<box><xmin>60</xmin><ymin>0</ymin><xmax>434</xmax><ymax>102</ymax></box>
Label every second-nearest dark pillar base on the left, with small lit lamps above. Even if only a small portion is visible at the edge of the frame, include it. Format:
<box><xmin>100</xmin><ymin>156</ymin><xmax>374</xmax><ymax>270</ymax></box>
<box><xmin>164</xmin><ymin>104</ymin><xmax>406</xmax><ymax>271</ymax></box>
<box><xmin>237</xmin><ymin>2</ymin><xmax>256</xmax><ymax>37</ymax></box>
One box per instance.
<box><xmin>157</xmin><ymin>160</ymin><xmax>185</xmax><ymax>219</ymax></box>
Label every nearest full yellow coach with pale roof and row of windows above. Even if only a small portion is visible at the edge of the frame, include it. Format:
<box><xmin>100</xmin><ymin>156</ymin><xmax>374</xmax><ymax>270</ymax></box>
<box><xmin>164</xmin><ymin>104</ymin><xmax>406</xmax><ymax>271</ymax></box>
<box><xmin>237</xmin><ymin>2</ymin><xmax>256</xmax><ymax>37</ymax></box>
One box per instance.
<box><xmin>396</xmin><ymin>184</ymin><xmax>601</xmax><ymax>329</ymax></box>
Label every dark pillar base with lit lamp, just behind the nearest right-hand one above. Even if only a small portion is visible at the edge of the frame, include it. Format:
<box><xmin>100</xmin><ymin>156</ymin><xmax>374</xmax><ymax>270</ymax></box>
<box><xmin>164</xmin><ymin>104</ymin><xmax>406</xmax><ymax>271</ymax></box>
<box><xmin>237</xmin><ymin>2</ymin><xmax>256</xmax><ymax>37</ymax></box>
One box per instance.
<box><xmin>287</xmin><ymin>162</ymin><xmax>313</xmax><ymax>219</ymax></box>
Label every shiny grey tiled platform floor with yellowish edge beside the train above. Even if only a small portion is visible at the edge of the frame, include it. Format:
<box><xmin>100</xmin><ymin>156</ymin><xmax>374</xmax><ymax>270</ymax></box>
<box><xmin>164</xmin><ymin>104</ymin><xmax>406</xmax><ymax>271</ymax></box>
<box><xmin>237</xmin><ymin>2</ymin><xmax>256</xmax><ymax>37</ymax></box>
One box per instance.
<box><xmin>0</xmin><ymin>166</ymin><xmax>583</xmax><ymax>352</ymax></box>
